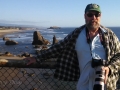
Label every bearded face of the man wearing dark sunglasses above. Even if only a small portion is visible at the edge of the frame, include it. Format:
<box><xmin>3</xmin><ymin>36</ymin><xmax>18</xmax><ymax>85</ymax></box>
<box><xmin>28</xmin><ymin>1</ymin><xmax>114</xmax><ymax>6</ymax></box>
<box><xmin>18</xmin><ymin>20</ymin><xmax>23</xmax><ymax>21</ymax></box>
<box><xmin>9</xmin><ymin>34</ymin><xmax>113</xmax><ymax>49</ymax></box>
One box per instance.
<box><xmin>84</xmin><ymin>11</ymin><xmax>101</xmax><ymax>30</ymax></box>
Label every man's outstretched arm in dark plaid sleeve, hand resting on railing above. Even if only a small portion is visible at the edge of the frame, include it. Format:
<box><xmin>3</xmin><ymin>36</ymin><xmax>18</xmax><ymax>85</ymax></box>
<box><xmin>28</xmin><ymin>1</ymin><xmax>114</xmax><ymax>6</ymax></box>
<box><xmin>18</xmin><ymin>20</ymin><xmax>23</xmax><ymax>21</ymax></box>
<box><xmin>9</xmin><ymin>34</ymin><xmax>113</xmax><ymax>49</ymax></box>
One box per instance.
<box><xmin>25</xmin><ymin>30</ymin><xmax>75</xmax><ymax>65</ymax></box>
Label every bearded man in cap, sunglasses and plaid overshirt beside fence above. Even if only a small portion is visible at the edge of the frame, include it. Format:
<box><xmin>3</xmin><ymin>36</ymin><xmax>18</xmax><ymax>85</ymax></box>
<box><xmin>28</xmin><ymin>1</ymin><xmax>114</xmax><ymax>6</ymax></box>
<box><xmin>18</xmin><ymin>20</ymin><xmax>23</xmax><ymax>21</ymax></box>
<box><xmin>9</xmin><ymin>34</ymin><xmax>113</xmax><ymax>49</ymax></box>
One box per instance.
<box><xmin>26</xmin><ymin>4</ymin><xmax>120</xmax><ymax>90</ymax></box>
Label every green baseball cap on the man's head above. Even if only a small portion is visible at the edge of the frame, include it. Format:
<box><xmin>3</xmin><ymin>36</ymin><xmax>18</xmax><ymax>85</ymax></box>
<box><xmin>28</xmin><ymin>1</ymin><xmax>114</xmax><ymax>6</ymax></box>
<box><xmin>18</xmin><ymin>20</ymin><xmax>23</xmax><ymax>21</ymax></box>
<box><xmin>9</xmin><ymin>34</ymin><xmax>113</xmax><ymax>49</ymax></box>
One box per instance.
<box><xmin>85</xmin><ymin>4</ymin><xmax>101</xmax><ymax>13</ymax></box>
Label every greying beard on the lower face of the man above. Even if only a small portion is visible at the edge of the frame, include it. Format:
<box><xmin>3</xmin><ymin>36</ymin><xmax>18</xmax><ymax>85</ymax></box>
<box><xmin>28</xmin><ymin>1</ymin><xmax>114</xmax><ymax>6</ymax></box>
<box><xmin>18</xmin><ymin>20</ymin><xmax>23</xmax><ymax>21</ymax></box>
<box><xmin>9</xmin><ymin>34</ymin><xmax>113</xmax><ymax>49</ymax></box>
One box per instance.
<box><xmin>86</xmin><ymin>20</ymin><xmax>100</xmax><ymax>30</ymax></box>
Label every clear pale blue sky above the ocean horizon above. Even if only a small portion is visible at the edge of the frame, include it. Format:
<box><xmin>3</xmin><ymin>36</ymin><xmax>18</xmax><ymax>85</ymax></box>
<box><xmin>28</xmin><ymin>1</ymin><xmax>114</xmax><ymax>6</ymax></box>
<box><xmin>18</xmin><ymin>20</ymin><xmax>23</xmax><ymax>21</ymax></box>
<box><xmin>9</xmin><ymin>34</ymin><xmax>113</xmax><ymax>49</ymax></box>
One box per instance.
<box><xmin>0</xmin><ymin>0</ymin><xmax>120</xmax><ymax>27</ymax></box>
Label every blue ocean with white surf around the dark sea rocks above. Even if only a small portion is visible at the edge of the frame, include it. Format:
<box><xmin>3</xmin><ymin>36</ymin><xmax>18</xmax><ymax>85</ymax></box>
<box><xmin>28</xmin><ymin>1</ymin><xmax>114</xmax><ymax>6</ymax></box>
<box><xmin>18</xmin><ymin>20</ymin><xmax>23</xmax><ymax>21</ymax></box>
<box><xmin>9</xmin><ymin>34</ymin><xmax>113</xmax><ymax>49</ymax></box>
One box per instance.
<box><xmin>0</xmin><ymin>27</ymin><xmax>120</xmax><ymax>54</ymax></box>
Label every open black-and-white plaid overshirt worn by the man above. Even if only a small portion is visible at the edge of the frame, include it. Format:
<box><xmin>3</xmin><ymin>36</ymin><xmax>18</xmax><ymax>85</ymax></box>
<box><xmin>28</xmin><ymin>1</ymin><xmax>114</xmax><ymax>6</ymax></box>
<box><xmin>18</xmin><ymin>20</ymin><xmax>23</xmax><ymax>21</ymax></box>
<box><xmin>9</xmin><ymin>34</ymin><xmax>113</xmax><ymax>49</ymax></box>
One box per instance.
<box><xmin>38</xmin><ymin>25</ymin><xmax>120</xmax><ymax>90</ymax></box>
